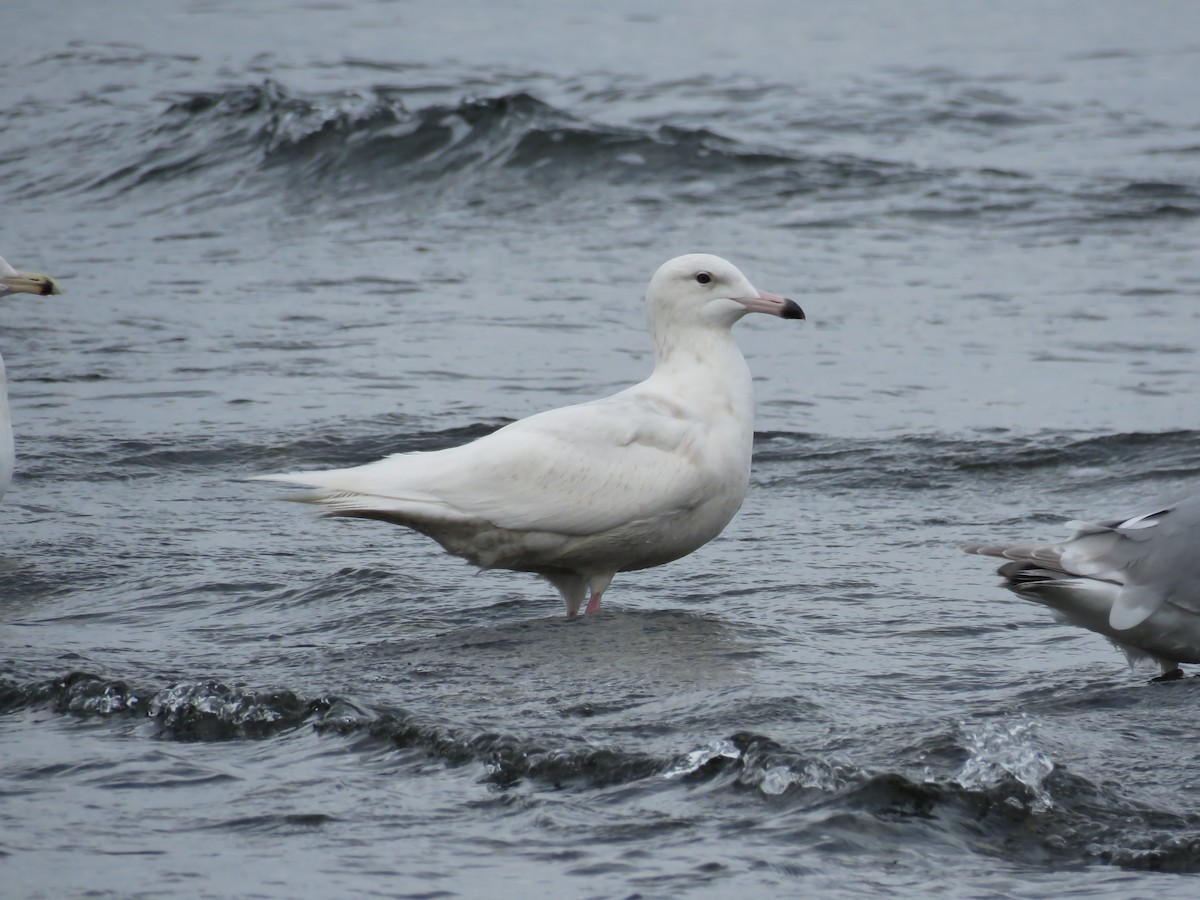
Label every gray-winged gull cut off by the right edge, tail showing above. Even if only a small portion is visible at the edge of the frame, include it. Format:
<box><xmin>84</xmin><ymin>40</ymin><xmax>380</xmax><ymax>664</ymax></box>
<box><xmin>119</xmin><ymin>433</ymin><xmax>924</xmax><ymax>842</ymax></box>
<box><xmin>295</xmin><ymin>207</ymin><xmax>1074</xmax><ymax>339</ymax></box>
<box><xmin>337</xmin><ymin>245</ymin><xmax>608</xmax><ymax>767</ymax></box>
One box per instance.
<box><xmin>964</xmin><ymin>493</ymin><xmax>1200</xmax><ymax>680</ymax></box>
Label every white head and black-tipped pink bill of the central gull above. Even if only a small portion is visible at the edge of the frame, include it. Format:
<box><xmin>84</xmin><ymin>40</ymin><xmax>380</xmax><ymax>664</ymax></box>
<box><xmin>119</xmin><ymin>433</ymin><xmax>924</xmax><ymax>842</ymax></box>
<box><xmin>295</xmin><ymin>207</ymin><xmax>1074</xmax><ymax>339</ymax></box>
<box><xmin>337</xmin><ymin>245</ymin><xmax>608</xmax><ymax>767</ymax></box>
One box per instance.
<box><xmin>646</xmin><ymin>253</ymin><xmax>804</xmax><ymax>330</ymax></box>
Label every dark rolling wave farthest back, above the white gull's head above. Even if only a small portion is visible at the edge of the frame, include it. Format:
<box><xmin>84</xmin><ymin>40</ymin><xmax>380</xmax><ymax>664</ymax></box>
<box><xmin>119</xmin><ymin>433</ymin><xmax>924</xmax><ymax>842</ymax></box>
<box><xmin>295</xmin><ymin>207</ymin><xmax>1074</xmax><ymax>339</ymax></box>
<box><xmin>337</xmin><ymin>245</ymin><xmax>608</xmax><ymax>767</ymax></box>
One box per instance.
<box><xmin>63</xmin><ymin>80</ymin><xmax>929</xmax><ymax>213</ymax></box>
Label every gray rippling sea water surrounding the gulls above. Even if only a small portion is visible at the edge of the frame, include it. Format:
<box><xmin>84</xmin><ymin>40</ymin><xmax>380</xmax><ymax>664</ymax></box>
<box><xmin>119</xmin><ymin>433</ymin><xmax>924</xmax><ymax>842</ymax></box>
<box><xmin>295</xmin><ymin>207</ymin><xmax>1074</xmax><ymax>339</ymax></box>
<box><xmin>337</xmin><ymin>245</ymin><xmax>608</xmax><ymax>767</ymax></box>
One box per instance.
<box><xmin>0</xmin><ymin>0</ymin><xmax>1200</xmax><ymax>898</ymax></box>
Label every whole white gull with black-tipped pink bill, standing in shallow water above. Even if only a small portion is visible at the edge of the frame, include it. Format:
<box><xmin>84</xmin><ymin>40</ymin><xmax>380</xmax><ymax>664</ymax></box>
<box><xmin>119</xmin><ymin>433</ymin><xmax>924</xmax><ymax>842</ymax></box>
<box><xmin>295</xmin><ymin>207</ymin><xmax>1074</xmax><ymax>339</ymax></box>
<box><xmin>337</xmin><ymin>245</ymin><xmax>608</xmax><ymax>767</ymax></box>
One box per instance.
<box><xmin>263</xmin><ymin>254</ymin><xmax>804</xmax><ymax>616</ymax></box>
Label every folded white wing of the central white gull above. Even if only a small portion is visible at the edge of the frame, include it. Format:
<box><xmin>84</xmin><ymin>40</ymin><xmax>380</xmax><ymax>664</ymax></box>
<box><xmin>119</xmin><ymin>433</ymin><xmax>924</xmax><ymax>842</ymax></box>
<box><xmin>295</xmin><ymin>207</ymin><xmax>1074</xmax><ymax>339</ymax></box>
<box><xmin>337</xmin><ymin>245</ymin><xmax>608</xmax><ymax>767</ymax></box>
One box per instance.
<box><xmin>264</xmin><ymin>390</ymin><xmax>720</xmax><ymax>535</ymax></box>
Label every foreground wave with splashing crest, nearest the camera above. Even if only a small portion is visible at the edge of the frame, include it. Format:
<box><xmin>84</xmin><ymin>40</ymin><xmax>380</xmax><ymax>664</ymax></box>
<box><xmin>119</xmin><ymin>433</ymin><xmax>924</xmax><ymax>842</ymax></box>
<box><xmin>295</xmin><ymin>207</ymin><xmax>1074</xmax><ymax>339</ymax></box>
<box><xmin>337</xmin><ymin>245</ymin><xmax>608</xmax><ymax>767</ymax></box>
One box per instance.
<box><xmin>7</xmin><ymin>672</ymin><xmax>1200</xmax><ymax>872</ymax></box>
